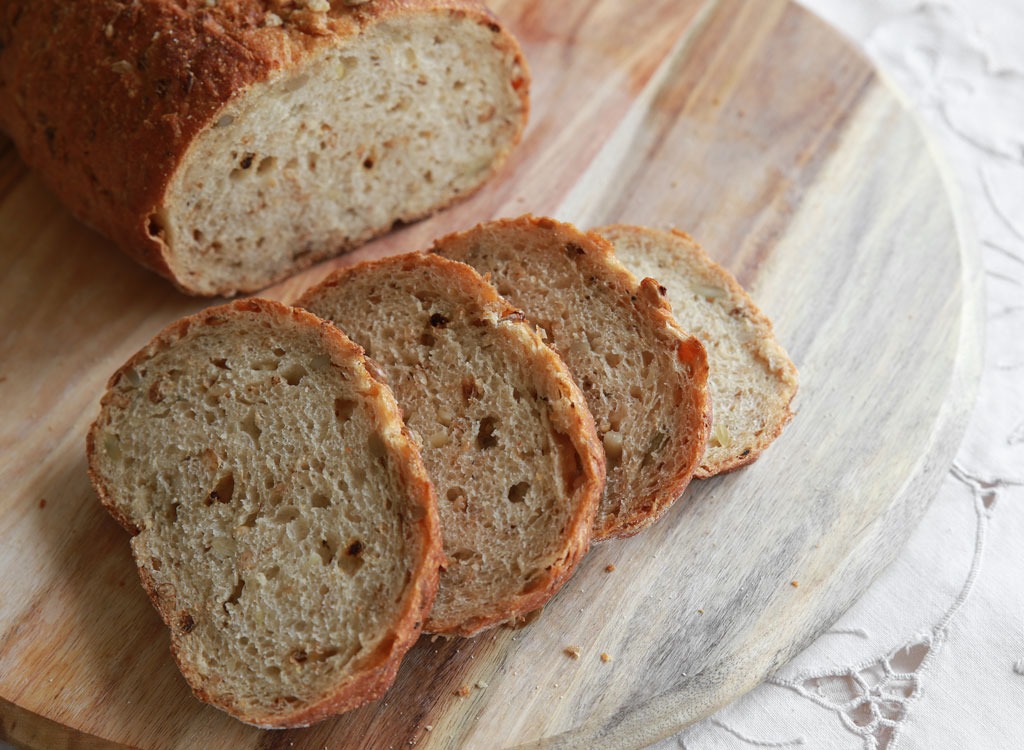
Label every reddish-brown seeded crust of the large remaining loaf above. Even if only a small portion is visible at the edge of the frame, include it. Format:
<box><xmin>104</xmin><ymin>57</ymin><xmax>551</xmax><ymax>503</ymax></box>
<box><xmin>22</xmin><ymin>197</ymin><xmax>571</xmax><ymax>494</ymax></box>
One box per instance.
<box><xmin>0</xmin><ymin>0</ymin><xmax>529</xmax><ymax>294</ymax></box>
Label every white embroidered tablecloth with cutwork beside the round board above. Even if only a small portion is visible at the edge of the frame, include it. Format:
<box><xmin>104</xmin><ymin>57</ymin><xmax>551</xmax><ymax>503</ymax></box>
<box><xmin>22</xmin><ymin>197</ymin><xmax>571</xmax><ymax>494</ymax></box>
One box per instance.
<box><xmin>654</xmin><ymin>0</ymin><xmax>1024</xmax><ymax>750</ymax></box>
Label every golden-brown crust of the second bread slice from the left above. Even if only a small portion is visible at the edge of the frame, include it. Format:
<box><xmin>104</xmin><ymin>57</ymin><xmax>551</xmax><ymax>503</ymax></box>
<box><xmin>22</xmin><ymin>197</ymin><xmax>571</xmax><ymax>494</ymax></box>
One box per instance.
<box><xmin>296</xmin><ymin>253</ymin><xmax>605</xmax><ymax>636</ymax></box>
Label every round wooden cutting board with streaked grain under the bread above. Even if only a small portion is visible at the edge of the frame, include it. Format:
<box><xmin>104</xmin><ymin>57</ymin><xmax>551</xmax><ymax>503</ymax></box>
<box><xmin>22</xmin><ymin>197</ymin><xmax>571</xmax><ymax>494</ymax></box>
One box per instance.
<box><xmin>0</xmin><ymin>0</ymin><xmax>980</xmax><ymax>750</ymax></box>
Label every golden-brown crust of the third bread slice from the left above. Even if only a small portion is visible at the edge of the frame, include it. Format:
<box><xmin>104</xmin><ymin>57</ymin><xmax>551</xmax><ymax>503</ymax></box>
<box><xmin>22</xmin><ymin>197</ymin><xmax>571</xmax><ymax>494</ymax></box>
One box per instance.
<box><xmin>430</xmin><ymin>214</ymin><xmax>712</xmax><ymax>541</ymax></box>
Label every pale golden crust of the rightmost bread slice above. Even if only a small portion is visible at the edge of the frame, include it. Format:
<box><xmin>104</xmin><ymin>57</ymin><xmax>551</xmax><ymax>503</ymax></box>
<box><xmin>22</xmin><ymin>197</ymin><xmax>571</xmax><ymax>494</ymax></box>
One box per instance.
<box><xmin>593</xmin><ymin>224</ymin><xmax>799</xmax><ymax>480</ymax></box>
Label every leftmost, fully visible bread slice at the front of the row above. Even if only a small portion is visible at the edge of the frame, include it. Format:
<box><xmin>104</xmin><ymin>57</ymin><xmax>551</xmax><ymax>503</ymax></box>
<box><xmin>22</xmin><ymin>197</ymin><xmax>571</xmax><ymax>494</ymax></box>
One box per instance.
<box><xmin>88</xmin><ymin>299</ymin><xmax>443</xmax><ymax>726</ymax></box>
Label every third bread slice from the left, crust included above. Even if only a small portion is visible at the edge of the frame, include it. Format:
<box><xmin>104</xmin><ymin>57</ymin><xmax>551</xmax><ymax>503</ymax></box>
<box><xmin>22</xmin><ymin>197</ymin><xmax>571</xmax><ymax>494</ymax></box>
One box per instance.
<box><xmin>432</xmin><ymin>216</ymin><xmax>711</xmax><ymax>539</ymax></box>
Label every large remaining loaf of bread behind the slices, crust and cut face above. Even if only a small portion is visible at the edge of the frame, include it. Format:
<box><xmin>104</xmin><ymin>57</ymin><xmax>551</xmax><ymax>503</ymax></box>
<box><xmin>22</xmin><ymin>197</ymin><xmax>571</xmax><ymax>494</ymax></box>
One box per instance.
<box><xmin>0</xmin><ymin>0</ymin><xmax>529</xmax><ymax>295</ymax></box>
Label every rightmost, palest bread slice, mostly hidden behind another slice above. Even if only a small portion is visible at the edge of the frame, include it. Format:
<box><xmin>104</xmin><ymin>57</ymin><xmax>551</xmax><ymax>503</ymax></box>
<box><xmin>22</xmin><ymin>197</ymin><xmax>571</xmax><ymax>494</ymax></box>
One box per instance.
<box><xmin>596</xmin><ymin>225</ymin><xmax>798</xmax><ymax>477</ymax></box>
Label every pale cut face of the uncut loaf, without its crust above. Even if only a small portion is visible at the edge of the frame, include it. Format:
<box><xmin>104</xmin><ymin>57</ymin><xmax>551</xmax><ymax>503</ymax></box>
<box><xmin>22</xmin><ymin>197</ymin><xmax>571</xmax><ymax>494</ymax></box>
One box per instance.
<box><xmin>161</xmin><ymin>11</ymin><xmax>528</xmax><ymax>295</ymax></box>
